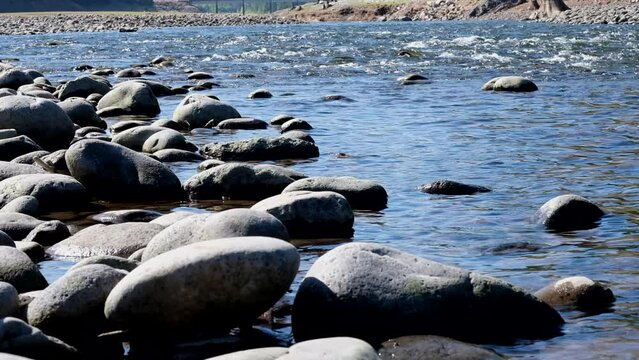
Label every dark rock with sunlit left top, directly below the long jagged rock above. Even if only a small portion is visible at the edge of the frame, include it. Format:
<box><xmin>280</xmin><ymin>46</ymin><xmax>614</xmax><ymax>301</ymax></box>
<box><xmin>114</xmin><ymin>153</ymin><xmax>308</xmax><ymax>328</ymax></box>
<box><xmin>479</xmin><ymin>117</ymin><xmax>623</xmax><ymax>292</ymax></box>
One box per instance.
<box><xmin>184</xmin><ymin>163</ymin><xmax>294</xmax><ymax>200</ymax></box>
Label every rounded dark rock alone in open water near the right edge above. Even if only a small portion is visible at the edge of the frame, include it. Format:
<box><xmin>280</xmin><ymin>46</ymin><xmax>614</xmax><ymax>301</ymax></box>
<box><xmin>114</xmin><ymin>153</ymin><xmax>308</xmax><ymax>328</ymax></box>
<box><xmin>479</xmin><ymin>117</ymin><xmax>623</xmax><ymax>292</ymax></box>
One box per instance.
<box><xmin>537</xmin><ymin>194</ymin><xmax>605</xmax><ymax>231</ymax></box>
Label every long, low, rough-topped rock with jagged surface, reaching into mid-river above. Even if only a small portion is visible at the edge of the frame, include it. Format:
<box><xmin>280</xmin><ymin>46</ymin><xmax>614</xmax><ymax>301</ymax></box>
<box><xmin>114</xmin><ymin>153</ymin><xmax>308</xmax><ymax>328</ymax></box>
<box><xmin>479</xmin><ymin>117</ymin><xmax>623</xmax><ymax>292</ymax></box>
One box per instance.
<box><xmin>202</xmin><ymin>137</ymin><xmax>319</xmax><ymax>161</ymax></box>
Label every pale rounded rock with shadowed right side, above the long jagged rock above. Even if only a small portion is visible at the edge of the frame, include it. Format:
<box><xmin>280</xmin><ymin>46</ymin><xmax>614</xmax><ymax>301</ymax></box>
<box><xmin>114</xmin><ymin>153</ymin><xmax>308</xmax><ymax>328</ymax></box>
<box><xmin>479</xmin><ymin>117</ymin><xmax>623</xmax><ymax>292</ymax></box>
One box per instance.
<box><xmin>173</xmin><ymin>95</ymin><xmax>242</xmax><ymax>129</ymax></box>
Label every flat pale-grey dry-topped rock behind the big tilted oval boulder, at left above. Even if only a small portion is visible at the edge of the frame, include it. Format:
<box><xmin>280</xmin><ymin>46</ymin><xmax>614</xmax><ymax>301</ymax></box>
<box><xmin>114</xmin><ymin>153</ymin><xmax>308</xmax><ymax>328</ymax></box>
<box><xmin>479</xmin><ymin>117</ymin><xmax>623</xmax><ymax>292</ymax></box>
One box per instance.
<box><xmin>47</xmin><ymin>222</ymin><xmax>164</xmax><ymax>258</ymax></box>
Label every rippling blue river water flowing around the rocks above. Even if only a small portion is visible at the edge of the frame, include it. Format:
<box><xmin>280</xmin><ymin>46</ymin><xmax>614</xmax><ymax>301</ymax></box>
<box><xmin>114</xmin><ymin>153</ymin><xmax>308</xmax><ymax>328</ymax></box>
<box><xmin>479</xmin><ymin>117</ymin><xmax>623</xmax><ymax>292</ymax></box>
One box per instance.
<box><xmin>0</xmin><ymin>21</ymin><xmax>639</xmax><ymax>359</ymax></box>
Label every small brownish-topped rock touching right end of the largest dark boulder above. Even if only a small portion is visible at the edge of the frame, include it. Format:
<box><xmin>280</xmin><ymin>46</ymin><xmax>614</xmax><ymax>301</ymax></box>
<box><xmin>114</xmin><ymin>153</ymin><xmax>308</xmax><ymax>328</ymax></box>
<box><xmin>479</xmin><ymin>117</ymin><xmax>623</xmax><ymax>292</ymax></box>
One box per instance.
<box><xmin>535</xmin><ymin>276</ymin><xmax>615</xmax><ymax>312</ymax></box>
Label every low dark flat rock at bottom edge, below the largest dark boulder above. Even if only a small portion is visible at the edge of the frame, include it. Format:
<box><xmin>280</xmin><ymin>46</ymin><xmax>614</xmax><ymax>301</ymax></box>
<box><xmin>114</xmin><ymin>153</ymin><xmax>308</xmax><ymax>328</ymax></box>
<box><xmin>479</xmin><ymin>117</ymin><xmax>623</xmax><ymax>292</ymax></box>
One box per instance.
<box><xmin>379</xmin><ymin>335</ymin><xmax>504</xmax><ymax>360</ymax></box>
